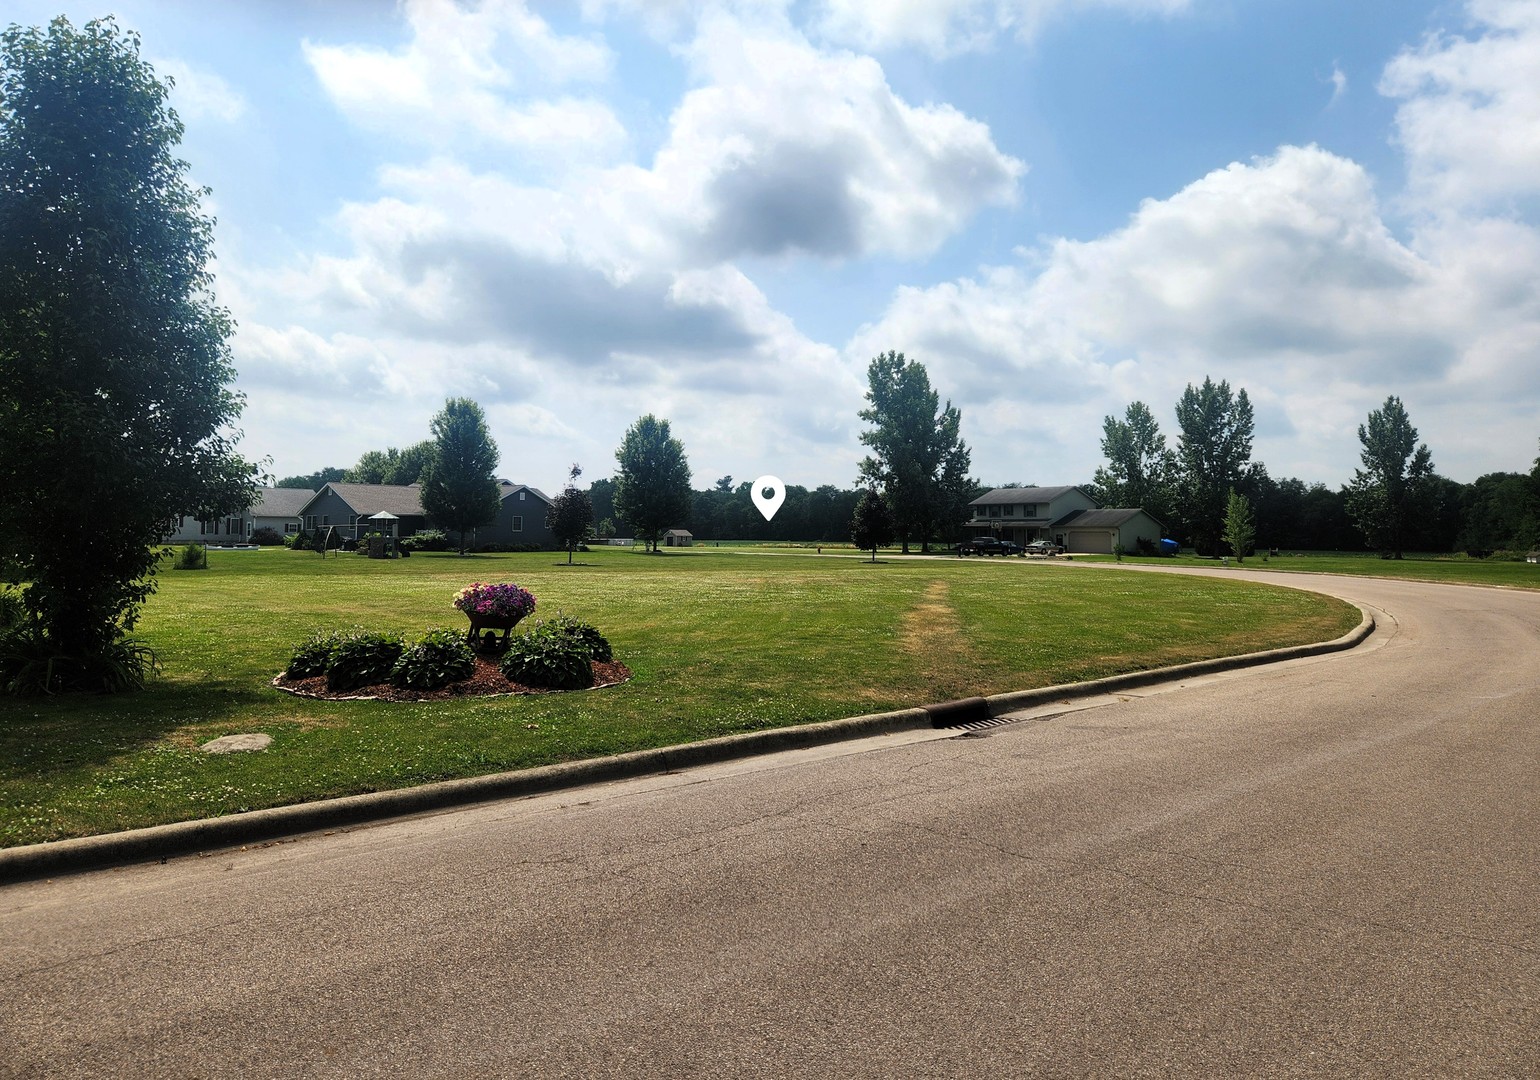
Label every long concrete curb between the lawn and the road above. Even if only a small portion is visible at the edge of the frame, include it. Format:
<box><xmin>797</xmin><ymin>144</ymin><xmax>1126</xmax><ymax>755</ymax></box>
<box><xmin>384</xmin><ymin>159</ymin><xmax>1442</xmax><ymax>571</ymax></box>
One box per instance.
<box><xmin>0</xmin><ymin>609</ymin><xmax>1374</xmax><ymax>884</ymax></box>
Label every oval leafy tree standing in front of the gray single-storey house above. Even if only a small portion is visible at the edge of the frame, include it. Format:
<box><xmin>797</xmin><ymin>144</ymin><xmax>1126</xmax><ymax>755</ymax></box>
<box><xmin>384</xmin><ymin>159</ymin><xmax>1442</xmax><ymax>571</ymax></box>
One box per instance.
<box><xmin>420</xmin><ymin>397</ymin><xmax>501</xmax><ymax>555</ymax></box>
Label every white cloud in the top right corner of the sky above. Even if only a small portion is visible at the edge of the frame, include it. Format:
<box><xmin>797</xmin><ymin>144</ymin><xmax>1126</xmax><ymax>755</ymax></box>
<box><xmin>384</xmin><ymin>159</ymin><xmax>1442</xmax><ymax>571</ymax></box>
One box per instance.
<box><xmin>1380</xmin><ymin>0</ymin><xmax>1540</xmax><ymax>213</ymax></box>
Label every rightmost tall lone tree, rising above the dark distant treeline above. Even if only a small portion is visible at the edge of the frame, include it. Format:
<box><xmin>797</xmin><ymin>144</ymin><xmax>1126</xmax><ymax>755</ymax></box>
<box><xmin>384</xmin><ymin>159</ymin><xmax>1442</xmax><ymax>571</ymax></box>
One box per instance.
<box><xmin>1348</xmin><ymin>394</ymin><xmax>1434</xmax><ymax>559</ymax></box>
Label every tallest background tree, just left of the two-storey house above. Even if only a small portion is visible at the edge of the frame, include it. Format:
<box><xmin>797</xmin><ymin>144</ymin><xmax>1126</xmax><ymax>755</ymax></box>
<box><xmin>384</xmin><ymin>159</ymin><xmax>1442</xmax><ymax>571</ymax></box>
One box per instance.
<box><xmin>861</xmin><ymin>351</ymin><xmax>973</xmax><ymax>553</ymax></box>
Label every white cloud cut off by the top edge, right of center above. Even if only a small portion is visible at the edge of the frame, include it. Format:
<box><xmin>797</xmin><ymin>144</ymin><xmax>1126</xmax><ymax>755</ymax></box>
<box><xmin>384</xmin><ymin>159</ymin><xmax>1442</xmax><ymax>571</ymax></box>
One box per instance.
<box><xmin>813</xmin><ymin>0</ymin><xmax>1192</xmax><ymax>57</ymax></box>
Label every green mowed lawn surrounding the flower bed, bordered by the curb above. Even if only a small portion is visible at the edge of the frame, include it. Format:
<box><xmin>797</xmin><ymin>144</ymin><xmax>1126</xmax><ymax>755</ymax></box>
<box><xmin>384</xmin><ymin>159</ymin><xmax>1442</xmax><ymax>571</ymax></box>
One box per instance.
<box><xmin>0</xmin><ymin>548</ymin><xmax>1358</xmax><ymax>846</ymax></box>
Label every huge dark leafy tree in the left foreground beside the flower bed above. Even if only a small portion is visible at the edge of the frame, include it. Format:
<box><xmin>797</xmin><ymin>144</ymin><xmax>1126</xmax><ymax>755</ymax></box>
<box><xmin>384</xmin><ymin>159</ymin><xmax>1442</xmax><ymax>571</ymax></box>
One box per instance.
<box><xmin>0</xmin><ymin>18</ymin><xmax>256</xmax><ymax>686</ymax></box>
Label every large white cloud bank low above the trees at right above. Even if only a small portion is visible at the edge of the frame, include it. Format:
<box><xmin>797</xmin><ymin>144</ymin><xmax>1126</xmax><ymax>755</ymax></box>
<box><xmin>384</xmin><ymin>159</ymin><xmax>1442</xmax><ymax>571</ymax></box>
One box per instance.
<box><xmin>847</xmin><ymin>146</ymin><xmax>1540</xmax><ymax>479</ymax></box>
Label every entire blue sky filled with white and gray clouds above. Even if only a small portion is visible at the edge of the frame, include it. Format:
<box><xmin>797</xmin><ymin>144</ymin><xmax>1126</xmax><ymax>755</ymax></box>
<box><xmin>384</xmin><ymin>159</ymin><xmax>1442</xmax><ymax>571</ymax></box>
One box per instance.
<box><xmin>8</xmin><ymin>0</ymin><xmax>1540</xmax><ymax>488</ymax></box>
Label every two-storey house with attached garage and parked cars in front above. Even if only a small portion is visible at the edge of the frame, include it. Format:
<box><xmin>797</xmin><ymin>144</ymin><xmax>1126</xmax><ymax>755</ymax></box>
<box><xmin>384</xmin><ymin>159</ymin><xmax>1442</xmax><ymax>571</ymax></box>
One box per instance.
<box><xmin>963</xmin><ymin>487</ymin><xmax>1161</xmax><ymax>555</ymax></box>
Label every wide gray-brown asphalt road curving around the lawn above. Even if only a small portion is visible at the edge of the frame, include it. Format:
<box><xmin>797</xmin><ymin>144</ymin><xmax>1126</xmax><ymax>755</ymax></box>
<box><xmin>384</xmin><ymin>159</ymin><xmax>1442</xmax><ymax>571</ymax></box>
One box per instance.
<box><xmin>0</xmin><ymin>567</ymin><xmax>1540</xmax><ymax>1078</ymax></box>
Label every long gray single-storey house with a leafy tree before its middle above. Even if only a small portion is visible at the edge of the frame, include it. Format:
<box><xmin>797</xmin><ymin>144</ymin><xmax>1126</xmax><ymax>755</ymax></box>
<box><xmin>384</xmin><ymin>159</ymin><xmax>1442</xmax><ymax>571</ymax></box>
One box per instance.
<box><xmin>291</xmin><ymin>481</ymin><xmax>556</xmax><ymax>547</ymax></box>
